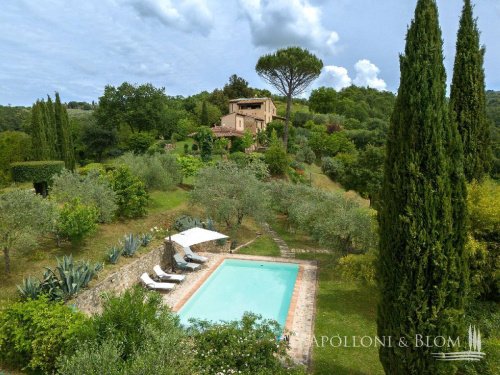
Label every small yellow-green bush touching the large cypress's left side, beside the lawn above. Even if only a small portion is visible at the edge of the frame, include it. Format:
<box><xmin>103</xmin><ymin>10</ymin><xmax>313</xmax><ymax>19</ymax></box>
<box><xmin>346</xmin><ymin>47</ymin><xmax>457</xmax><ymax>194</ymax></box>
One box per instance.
<box><xmin>337</xmin><ymin>251</ymin><xmax>377</xmax><ymax>285</ymax></box>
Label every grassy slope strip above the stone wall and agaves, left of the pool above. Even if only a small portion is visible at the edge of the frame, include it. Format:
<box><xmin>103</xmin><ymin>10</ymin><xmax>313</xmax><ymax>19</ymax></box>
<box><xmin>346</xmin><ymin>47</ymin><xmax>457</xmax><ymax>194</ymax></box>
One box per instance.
<box><xmin>0</xmin><ymin>188</ymin><xmax>188</xmax><ymax>305</ymax></box>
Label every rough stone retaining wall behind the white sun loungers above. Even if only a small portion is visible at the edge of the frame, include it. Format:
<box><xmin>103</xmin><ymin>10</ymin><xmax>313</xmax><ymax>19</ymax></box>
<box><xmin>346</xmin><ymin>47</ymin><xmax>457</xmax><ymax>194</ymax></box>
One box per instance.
<box><xmin>72</xmin><ymin>245</ymin><xmax>170</xmax><ymax>315</ymax></box>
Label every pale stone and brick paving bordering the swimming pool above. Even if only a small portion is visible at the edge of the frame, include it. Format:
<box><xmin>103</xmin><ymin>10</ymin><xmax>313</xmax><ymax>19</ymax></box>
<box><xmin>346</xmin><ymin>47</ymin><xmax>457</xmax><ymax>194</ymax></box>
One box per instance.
<box><xmin>163</xmin><ymin>253</ymin><xmax>317</xmax><ymax>366</ymax></box>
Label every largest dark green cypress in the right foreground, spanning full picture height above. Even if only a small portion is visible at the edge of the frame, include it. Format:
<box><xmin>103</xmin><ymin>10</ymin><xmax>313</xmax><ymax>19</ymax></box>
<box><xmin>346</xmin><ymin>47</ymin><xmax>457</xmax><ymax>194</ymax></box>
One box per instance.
<box><xmin>377</xmin><ymin>0</ymin><xmax>467</xmax><ymax>375</ymax></box>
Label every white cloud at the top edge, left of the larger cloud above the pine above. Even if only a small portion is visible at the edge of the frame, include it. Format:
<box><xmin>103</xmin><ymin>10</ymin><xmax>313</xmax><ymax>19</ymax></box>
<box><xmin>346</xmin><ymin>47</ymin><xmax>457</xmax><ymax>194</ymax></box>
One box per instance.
<box><xmin>126</xmin><ymin>0</ymin><xmax>214</xmax><ymax>36</ymax></box>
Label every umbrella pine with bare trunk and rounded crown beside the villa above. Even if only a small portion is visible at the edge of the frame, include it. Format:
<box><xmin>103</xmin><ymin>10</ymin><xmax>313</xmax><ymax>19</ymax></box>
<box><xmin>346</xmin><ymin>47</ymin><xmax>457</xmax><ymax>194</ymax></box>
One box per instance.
<box><xmin>255</xmin><ymin>47</ymin><xmax>323</xmax><ymax>149</ymax></box>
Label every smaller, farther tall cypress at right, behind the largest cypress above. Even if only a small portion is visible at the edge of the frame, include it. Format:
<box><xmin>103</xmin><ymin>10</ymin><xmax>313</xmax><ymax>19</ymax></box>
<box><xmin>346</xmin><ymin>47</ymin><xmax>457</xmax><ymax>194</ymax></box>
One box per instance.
<box><xmin>450</xmin><ymin>0</ymin><xmax>491</xmax><ymax>181</ymax></box>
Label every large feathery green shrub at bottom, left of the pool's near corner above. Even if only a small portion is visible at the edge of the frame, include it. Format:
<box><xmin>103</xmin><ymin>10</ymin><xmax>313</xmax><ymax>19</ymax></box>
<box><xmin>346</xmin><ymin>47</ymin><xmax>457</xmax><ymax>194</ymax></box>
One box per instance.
<box><xmin>58</xmin><ymin>287</ymin><xmax>194</xmax><ymax>375</ymax></box>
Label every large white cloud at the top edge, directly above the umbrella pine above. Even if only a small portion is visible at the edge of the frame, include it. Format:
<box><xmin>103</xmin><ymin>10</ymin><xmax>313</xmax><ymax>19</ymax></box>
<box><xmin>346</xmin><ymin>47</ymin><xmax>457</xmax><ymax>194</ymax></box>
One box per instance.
<box><xmin>239</xmin><ymin>0</ymin><xmax>339</xmax><ymax>54</ymax></box>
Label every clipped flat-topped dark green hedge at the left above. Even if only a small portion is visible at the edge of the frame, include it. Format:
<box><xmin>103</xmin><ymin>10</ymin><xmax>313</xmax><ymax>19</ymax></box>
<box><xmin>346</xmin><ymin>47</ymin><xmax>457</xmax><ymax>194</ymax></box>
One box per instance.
<box><xmin>10</xmin><ymin>160</ymin><xmax>64</xmax><ymax>183</ymax></box>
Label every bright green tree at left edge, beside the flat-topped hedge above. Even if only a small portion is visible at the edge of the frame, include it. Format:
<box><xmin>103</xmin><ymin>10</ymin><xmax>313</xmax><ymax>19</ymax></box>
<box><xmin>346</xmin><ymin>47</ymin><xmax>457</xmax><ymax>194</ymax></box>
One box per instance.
<box><xmin>0</xmin><ymin>131</ymin><xmax>31</xmax><ymax>185</ymax></box>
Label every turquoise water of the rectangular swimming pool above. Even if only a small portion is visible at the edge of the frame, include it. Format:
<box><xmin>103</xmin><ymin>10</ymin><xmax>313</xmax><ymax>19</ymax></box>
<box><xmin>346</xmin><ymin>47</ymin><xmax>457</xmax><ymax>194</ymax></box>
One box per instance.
<box><xmin>179</xmin><ymin>259</ymin><xmax>299</xmax><ymax>327</ymax></box>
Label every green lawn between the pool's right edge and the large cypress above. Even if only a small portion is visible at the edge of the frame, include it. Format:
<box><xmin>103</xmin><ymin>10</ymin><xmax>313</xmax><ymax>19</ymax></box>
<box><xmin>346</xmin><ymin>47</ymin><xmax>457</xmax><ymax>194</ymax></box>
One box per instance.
<box><xmin>297</xmin><ymin>253</ymin><xmax>384</xmax><ymax>375</ymax></box>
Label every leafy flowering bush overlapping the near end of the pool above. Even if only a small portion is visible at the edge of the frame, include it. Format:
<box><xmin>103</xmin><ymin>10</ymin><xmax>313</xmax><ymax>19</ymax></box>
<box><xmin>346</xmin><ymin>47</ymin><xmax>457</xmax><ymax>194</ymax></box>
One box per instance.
<box><xmin>188</xmin><ymin>313</ymin><xmax>298</xmax><ymax>375</ymax></box>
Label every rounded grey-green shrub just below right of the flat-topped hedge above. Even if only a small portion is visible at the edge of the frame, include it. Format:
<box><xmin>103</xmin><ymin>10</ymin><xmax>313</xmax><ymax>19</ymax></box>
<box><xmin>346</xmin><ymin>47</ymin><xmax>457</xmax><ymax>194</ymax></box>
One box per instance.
<box><xmin>51</xmin><ymin>170</ymin><xmax>118</xmax><ymax>223</ymax></box>
